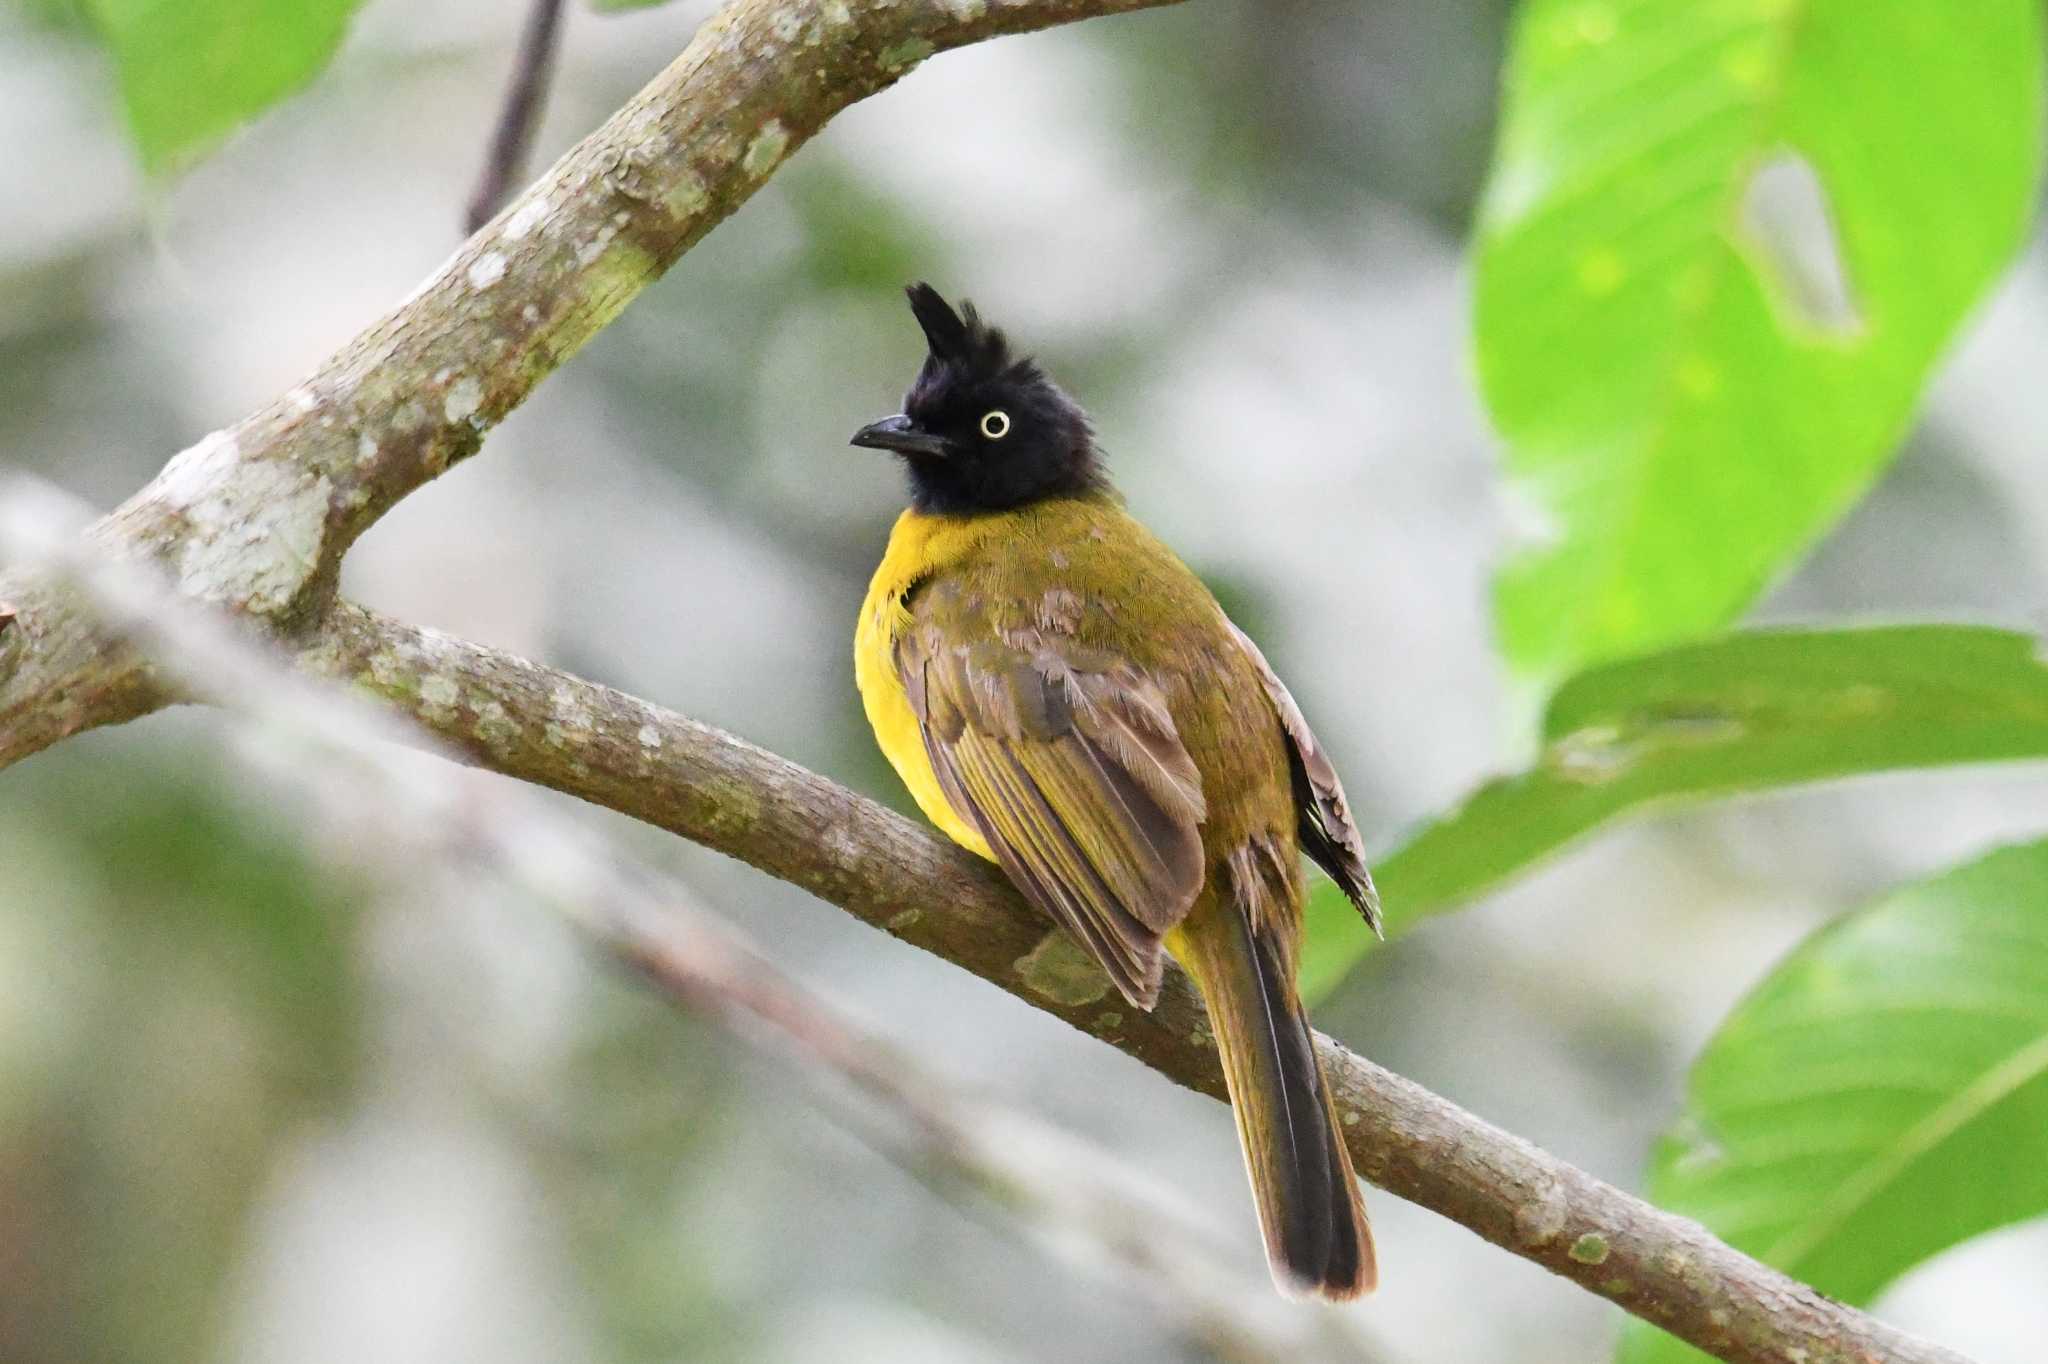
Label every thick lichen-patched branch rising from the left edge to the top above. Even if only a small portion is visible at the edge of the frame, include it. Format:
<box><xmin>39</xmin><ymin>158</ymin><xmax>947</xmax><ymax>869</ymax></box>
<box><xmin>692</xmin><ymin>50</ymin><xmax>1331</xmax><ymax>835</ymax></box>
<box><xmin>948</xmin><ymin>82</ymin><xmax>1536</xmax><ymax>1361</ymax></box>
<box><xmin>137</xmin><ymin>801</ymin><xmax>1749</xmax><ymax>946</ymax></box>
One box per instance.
<box><xmin>0</xmin><ymin>0</ymin><xmax>1171</xmax><ymax>768</ymax></box>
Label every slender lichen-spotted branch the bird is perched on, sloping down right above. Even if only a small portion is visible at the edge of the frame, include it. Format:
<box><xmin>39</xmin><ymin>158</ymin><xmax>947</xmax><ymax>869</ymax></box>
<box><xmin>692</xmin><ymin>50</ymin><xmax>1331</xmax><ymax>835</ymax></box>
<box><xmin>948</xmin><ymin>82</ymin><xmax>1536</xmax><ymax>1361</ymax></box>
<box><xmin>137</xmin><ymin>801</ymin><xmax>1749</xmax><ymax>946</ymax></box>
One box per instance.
<box><xmin>301</xmin><ymin>602</ymin><xmax>1962</xmax><ymax>1364</ymax></box>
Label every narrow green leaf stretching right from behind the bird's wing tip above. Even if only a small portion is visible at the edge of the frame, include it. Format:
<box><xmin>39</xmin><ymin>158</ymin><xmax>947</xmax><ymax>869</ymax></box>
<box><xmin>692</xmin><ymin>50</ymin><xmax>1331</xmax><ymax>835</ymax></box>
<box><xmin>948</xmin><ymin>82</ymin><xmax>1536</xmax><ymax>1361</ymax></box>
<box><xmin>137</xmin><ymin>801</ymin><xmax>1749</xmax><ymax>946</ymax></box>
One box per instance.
<box><xmin>1303</xmin><ymin>625</ymin><xmax>2048</xmax><ymax>995</ymax></box>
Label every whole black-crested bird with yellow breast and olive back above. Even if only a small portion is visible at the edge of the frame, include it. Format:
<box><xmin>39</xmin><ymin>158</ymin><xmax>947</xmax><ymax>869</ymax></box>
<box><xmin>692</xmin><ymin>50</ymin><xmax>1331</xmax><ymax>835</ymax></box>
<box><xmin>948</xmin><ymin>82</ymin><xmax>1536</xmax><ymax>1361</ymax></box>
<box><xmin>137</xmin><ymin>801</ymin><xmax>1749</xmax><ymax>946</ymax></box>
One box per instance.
<box><xmin>852</xmin><ymin>283</ymin><xmax>1380</xmax><ymax>1301</ymax></box>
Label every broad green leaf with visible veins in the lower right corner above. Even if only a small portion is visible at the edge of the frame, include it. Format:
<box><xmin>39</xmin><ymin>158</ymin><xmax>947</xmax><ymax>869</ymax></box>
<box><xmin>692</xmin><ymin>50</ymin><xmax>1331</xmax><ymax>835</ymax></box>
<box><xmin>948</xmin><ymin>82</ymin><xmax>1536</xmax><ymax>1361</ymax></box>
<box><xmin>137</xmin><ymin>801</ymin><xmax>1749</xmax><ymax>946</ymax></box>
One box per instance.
<box><xmin>1620</xmin><ymin>840</ymin><xmax>2048</xmax><ymax>1364</ymax></box>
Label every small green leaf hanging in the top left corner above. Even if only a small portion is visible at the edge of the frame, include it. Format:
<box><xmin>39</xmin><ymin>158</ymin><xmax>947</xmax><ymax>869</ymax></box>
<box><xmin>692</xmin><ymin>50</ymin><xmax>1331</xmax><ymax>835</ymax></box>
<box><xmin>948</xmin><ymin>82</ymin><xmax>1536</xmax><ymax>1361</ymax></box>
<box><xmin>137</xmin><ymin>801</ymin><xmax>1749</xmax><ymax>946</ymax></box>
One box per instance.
<box><xmin>86</xmin><ymin>0</ymin><xmax>362</xmax><ymax>174</ymax></box>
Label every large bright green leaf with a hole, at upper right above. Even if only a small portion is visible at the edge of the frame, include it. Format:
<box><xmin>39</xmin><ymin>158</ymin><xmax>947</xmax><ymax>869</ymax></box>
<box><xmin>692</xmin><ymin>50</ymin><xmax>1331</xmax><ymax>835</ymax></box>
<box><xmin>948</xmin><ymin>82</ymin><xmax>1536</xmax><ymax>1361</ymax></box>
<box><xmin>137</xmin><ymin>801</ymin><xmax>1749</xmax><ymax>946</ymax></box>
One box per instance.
<box><xmin>1475</xmin><ymin>0</ymin><xmax>2042</xmax><ymax>682</ymax></box>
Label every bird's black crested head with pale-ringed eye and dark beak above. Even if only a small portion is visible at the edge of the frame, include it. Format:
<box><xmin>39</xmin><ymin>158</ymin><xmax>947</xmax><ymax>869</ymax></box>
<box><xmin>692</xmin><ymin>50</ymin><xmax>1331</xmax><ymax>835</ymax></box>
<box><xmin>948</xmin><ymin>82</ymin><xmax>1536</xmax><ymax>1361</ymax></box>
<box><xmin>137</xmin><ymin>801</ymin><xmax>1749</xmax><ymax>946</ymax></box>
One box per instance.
<box><xmin>854</xmin><ymin>283</ymin><xmax>1106</xmax><ymax>516</ymax></box>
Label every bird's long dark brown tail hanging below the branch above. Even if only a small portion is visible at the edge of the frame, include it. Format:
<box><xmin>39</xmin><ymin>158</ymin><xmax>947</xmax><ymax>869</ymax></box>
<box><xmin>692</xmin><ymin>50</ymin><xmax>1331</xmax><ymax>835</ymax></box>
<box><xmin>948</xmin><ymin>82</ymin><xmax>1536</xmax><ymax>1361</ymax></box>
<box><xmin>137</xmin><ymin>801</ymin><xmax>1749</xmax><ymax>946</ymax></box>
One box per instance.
<box><xmin>1180</xmin><ymin>903</ymin><xmax>1378</xmax><ymax>1301</ymax></box>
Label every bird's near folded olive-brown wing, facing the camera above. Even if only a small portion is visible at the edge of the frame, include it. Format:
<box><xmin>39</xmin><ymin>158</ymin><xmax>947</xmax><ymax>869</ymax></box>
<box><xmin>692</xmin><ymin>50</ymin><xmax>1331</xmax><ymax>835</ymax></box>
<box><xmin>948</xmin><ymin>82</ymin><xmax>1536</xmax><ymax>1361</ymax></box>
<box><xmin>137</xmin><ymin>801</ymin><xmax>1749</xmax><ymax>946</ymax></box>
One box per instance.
<box><xmin>897</xmin><ymin>627</ymin><xmax>1204</xmax><ymax>1008</ymax></box>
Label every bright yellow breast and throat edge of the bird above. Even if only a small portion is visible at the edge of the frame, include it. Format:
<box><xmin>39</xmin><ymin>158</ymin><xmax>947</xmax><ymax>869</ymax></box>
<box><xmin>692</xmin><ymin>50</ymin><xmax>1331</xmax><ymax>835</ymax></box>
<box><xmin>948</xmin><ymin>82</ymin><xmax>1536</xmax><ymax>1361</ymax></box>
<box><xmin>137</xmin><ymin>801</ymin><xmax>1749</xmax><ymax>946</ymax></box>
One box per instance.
<box><xmin>854</xmin><ymin>512</ymin><xmax>995</xmax><ymax>862</ymax></box>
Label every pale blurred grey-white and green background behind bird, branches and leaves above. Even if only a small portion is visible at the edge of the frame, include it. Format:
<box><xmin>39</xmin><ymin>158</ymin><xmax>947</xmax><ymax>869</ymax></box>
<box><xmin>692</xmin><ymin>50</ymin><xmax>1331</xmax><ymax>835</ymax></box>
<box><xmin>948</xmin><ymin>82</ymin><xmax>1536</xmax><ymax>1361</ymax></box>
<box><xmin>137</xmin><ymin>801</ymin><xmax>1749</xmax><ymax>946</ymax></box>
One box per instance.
<box><xmin>0</xmin><ymin>0</ymin><xmax>2048</xmax><ymax>1364</ymax></box>
